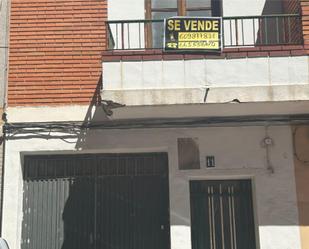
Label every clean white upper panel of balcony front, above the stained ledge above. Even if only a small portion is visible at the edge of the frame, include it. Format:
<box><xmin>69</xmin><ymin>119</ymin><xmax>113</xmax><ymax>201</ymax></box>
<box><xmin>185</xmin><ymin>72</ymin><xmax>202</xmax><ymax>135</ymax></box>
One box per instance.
<box><xmin>103</xmin><ymin>56</ymin><xmax>309</xmax><ymax>90</ymax></box>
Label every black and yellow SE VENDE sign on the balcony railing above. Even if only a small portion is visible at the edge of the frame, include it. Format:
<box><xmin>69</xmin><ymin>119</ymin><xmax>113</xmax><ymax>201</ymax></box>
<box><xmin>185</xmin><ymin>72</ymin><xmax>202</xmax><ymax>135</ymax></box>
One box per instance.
<box><xmin>164</xmin><ymin>17</ymin><xmax>221</xmax><ymax>51</ymax></box>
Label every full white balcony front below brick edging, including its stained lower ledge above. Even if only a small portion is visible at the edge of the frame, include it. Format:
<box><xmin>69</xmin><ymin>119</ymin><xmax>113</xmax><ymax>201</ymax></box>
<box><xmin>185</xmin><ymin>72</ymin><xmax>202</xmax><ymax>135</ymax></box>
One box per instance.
<box><xmin>102</xmin><ymin>56</ymin><xmax>309</xmax><ymax>105</ymax></box>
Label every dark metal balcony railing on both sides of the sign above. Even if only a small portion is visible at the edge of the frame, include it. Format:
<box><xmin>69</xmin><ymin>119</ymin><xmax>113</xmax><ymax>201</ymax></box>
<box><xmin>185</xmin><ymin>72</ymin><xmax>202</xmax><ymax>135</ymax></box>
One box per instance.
<box><xmin>107</xmin><ymin>14</ymin><xmax>302</xmax><ymax>50</ymax></box>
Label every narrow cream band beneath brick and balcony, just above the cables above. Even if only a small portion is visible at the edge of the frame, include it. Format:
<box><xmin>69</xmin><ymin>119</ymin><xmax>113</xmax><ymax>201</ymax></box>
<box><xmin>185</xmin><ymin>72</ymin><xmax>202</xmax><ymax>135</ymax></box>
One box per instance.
<box><xmin>7</xmin><ymin>101</ymin><xmax>309</xmax><ymax>123</ymax></box>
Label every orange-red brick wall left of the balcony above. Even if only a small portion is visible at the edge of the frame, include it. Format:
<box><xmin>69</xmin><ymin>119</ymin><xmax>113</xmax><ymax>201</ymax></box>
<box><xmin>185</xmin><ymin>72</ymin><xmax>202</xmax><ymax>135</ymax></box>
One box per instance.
<box><xmin>8</xmin><ymin>0</ymin><xmax>107</xmax><ymax>106</ymax></box>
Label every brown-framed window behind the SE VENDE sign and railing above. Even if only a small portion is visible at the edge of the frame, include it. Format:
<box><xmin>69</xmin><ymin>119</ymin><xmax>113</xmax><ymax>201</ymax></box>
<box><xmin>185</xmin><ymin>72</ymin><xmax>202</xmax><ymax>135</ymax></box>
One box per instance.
<box><xmin>145</xmin><ymin>0</ymin><xmax>221</xmax><ymax>48</ymax></box>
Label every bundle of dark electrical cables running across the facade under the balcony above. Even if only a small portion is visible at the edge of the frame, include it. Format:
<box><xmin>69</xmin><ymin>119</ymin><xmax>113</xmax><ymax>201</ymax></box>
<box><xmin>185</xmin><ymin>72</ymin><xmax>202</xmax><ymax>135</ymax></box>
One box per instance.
<box><xmin>4</xmin><ymin>114</ymin><xmax>309</xmax><ymax>138</ymax></box>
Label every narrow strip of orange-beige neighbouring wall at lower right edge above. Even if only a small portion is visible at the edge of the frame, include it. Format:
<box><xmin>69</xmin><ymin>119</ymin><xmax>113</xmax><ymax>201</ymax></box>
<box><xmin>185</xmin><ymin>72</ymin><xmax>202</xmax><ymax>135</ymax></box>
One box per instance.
<box><xmin>293</xmin><ymin>126</ymin><xmax>309</xmax><ymax>249</ymax></box>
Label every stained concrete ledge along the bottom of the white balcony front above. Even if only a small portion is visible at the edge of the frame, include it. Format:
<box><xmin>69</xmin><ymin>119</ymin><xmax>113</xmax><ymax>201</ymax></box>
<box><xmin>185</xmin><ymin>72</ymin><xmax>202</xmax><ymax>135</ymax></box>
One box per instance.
<box><xmin>102</xmin><ymin>84</ymin><xmax>309</xmax><ymax>106</ymax></box>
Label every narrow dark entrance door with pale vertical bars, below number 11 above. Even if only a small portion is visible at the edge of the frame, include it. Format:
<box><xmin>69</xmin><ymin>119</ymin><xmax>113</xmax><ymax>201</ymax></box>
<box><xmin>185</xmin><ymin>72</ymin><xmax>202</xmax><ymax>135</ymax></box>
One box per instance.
<box><xmin>190</xmin><ymin>180</ymin><xmax>256</xmax><ymax>249</ymax></box>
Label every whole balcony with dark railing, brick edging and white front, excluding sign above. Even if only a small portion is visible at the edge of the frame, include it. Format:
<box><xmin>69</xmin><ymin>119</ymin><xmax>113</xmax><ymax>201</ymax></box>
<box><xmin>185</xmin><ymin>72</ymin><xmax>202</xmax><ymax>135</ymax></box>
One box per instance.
<box><xmin>102</xmin><ymin>14</ymin><xmax>309</xmax><ymax>106</ymax></box>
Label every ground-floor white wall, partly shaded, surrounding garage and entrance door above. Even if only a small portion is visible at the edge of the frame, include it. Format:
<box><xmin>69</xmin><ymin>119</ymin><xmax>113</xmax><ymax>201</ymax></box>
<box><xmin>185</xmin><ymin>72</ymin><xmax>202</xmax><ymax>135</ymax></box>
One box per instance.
<box><xmin>3</xmin><ymin>126</ymin><xmax>300</xmax><ymax>249</ymax></box>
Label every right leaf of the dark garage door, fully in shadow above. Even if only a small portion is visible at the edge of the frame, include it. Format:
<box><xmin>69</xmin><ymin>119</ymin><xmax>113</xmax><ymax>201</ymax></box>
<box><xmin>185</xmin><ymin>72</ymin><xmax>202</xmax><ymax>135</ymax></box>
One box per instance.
<box><xmin>96</xmin><ymin>154</ymin><xmax>170</xmax><ymax>249</ymax></box>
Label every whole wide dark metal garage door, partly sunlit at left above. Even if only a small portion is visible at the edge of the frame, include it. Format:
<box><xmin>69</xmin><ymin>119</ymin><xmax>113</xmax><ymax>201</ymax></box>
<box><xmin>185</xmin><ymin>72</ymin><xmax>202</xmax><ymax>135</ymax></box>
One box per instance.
<box><xmin>22</xmin><ymin>153</ymin><xmax>170</xmax><ymax>249</ymax></box>
